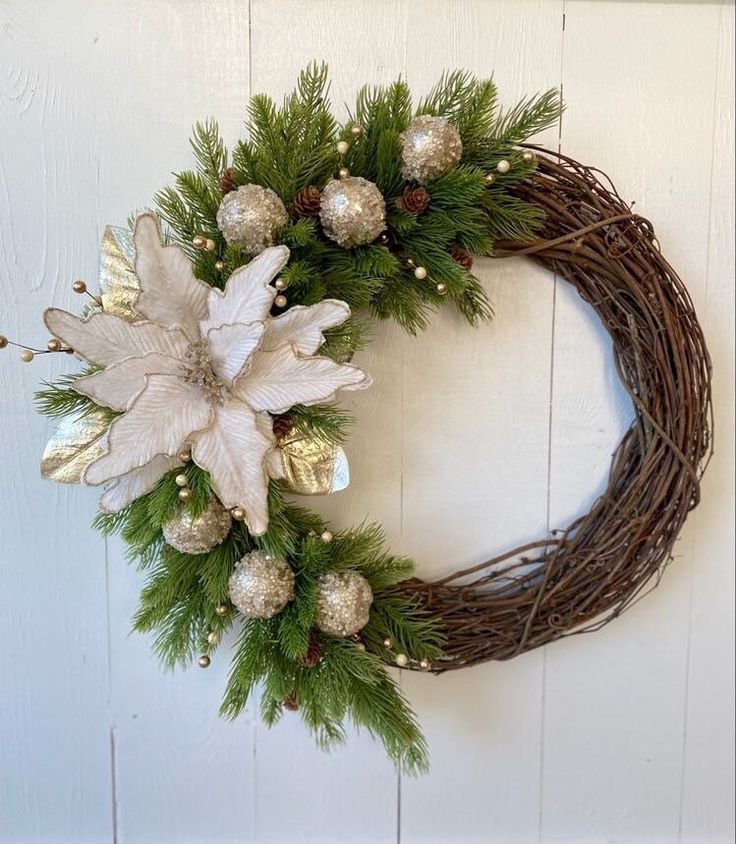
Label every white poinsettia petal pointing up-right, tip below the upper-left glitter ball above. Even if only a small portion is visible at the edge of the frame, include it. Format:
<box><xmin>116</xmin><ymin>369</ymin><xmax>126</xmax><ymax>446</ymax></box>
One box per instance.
<box><xmin>200</xmin><ymin>246</ymin><xmax>289</xmax><ymax>335</ymax></box>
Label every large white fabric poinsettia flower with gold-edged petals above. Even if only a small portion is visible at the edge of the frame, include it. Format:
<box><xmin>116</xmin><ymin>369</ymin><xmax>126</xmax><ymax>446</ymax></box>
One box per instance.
<box><xmin>45</xmin><ymin>213</ymin><xmax>370</xmax><ymax>535</ymax></box>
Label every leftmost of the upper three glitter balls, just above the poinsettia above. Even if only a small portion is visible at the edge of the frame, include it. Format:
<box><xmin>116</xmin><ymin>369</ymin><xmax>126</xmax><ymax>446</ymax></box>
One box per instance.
<box><xmin>217</xmin><ymin>185</ymin><xmax>289</xmax><ymax>255</ymax></box>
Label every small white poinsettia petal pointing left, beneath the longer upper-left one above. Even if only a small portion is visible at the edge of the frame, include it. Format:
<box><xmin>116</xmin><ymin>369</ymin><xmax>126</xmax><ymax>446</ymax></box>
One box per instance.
<box><xmin>72</xmin><ymin>352</ymin><xmax>182</xmax><ymax>410</ymax></box>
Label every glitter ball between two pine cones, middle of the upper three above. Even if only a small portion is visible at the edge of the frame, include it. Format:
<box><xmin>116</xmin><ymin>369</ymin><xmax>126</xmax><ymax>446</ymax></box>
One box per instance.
<box><xmin>319</xmin><ymin>176</ymin><xmax>386</xmax><ymax>249</ymax></box>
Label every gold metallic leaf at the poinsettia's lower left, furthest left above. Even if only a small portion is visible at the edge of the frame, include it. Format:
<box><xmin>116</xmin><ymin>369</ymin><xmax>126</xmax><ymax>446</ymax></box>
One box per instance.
<box><xmin>41</xmin><ymin>411</ymin><xmax>110</xmax><ymax>484</ymax></box>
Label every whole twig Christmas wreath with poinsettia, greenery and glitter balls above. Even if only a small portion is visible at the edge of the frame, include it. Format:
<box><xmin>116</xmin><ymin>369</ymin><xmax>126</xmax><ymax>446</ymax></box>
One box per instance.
<box><xmin>0</xmin><ymin>65</ymin><xmax>712</xmax><ymax>771</ymax></box>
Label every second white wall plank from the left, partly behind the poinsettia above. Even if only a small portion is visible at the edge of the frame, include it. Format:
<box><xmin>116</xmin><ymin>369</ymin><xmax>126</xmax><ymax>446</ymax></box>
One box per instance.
<box><xmin>87</xmin><ymin>0</ymin><xmax>256</xmax><ymax>844</ymax></box>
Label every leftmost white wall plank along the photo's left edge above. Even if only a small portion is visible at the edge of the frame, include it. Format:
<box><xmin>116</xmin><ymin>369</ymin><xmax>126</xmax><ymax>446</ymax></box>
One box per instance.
<box><xmin>0</xmin><ymin>2</ymin><xmax>113</xmax><ymax>844</ymax></box>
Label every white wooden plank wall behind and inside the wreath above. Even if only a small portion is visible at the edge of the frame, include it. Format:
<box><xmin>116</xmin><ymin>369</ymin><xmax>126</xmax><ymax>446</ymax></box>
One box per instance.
<box><xmin>0</xmin><ymin>0</ymin><xmax>734</xmax><ymax>844</ymax></box>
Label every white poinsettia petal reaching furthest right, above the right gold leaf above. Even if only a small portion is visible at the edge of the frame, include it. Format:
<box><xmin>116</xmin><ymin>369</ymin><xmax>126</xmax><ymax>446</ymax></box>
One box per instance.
<box><xmin>233</xmin><ymin>345</ymin><xmax>370</xmax><ymax>413</ymax></box>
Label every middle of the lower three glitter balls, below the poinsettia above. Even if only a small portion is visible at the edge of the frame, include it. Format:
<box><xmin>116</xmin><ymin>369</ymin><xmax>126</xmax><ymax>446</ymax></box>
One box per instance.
<box><xmin>228</xmin><ymin>551</ymin><xmax>294</xmax><ymax>618</ymax></box>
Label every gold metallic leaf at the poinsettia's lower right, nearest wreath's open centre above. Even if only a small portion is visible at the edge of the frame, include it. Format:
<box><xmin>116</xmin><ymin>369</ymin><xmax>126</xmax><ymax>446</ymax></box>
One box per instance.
<box><xmin>281</xmin><ymin>437</ymin><xmax>350</xmax><ymax>495</ymax></box>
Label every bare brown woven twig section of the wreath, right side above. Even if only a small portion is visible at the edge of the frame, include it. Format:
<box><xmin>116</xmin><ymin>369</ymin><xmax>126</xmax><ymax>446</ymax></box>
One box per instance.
<box><xmin>402</xmin><ymin>149</ymin><xmax>712</xmax><ymax>671</ymax></box>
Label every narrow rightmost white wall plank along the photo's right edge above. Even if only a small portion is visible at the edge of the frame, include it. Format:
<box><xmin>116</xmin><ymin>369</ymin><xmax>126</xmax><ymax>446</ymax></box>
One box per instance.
<box><xmin>680</xmin><ymin>4</ymin><xmax>736</xmax><ymax>842</ymax></box>
